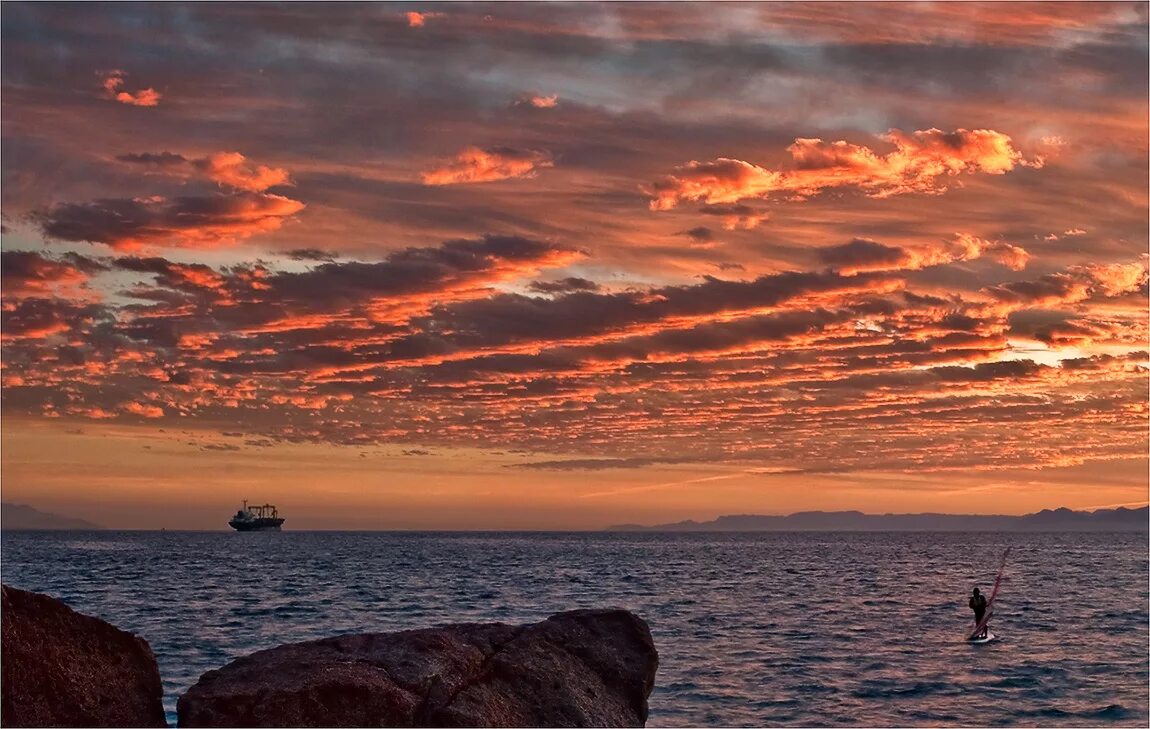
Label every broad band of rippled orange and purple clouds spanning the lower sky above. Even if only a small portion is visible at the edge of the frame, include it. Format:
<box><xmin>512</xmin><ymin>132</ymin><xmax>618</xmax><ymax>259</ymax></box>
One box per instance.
<box><xmin>3</xmin><ymin>236</ymin><xmax>1148</xmax><ymax>470</ymax></box>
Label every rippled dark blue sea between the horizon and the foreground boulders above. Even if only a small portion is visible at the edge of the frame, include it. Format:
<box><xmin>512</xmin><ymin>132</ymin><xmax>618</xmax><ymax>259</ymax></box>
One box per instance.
<box><xmin>0</xmin><ymin>531</ymin><xmax>1150</xmax><ymax>727</ymax></box>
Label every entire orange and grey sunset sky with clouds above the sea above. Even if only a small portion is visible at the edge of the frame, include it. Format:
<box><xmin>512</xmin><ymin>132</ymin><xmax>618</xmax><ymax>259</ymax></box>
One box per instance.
<box><xmin>0</xmin><ymin>2</ymin><xmax>1150</xmax><ymax>529</ymax></box>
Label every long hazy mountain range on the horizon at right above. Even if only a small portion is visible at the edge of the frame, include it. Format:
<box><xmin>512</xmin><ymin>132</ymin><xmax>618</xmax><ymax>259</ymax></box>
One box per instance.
<box><xmin>607</xmin><ymin>506</ymin><xmax>1150</xmax><ymax>531</ymax></box>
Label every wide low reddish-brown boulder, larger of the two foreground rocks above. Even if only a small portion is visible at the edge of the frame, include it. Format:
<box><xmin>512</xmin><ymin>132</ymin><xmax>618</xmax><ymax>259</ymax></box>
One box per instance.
<box><xmin>178</xmin><ymin>609</ymin><xmax>659</xmax><ymax>727</ymax></box>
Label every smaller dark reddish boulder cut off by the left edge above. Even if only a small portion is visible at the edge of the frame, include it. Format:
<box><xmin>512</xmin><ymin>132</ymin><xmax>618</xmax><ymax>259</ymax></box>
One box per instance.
<box><xmin>0</xmin><ymin>585</ymin><xmax>168</xmax><ymax>727</ymax></box>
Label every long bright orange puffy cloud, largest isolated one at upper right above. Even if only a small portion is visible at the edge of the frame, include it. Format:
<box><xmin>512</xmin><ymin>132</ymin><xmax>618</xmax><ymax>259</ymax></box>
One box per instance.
<box><xmin>647</xmin><ymin>129</ymin><xmax>1036</xmax><ymax>210</ymax></box>
